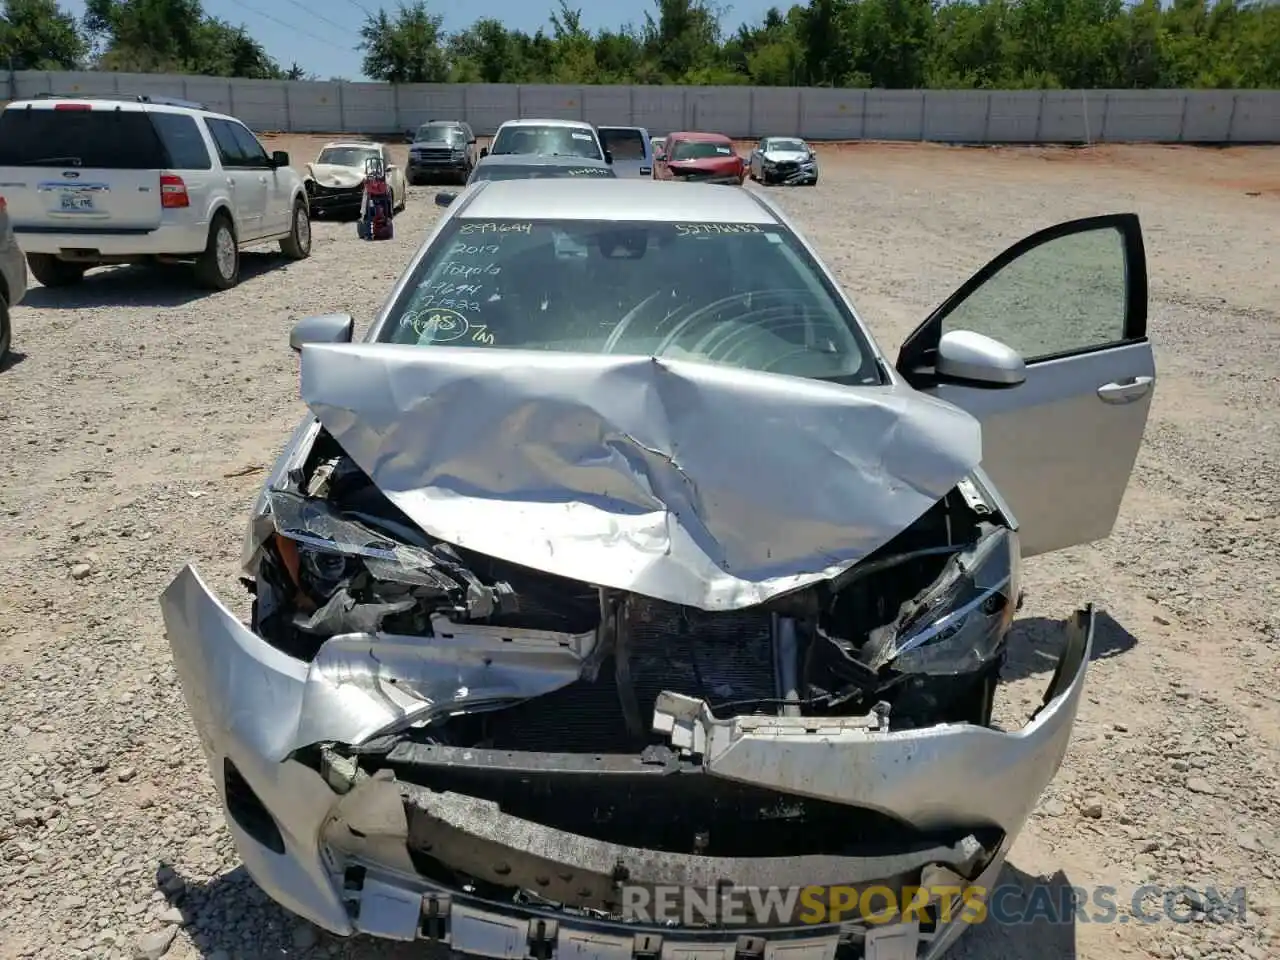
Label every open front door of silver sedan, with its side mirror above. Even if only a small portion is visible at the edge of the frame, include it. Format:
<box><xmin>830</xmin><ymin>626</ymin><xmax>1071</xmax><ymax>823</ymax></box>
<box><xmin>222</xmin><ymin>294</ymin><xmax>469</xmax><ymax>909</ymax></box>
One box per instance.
<box><xmin>897</xmin><ymin>214</ymin><xmax>1156</xmax><ymax>557</ymax></box>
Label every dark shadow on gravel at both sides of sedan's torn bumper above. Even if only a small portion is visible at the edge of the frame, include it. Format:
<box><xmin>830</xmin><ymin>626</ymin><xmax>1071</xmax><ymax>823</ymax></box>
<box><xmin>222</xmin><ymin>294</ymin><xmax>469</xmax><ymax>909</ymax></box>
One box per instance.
<box><xmin>156</xmin><ymin>864</ymin><xmax>1080</xmax><ymax>960</ymax></box>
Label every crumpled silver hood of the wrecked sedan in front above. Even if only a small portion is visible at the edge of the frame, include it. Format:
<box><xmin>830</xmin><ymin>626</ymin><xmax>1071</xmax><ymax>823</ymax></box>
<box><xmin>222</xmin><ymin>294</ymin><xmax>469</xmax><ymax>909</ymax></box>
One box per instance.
<box><xmin>302</xmin><ymin>343</ymin><xmax>982</xmax><ymax>609</ymax></box>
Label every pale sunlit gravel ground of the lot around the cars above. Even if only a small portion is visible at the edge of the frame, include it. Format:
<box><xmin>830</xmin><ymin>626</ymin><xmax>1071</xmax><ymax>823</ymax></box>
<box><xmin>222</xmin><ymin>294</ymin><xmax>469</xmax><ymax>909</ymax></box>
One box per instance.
<box><xmin>0</xmin><ymin>138</ymin><xmax>1280</xmax><ymax>960</ymax></box>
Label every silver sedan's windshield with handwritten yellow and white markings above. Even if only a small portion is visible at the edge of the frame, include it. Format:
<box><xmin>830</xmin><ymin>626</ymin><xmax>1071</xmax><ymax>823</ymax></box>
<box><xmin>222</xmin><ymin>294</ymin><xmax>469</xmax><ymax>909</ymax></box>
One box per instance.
<box><xmin>378</xmin><ymin>219</ymin><xmax>882</xmax><ymax>384</ymax></box>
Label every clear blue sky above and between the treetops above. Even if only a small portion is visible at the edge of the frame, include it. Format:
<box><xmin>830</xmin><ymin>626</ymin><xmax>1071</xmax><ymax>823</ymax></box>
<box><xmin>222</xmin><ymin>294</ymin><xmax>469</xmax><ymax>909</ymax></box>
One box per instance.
<box><xmin>59</xmin><ymin>0</ymin><xmax>790</xmax><ymax>79</ymax></box>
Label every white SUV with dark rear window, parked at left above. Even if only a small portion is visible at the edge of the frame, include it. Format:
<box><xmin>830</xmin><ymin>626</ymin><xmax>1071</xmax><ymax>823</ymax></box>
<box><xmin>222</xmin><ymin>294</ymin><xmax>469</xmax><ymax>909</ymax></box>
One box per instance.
<box><xmin>0</xmin><ymin>96</ymin><xmax>311</xmax><ymax>289</ymax></box>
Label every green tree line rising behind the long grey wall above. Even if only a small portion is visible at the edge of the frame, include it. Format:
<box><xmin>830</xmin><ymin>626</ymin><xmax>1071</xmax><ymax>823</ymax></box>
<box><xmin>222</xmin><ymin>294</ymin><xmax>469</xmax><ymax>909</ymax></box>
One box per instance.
<box><xmin>0</xmin><ymin>0</ymin><xmax>1280</xmax><ymax>90</ymax></box>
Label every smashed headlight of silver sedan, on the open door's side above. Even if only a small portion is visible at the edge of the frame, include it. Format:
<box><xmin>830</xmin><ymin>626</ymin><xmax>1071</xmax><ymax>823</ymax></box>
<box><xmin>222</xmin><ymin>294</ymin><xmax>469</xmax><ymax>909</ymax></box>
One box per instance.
<box><xmin>863</xmin><ymin>525</ymin><xmax>1021</xmax><ymax>676</ymax></box>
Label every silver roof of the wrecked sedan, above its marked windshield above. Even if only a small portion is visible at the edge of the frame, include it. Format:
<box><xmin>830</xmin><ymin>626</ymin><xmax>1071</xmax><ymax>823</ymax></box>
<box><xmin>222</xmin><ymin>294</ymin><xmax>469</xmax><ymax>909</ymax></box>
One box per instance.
<box><xmin>454</xmin><ymin>178</ymin><xmax>780</xmax><ymax>224</ymax></box>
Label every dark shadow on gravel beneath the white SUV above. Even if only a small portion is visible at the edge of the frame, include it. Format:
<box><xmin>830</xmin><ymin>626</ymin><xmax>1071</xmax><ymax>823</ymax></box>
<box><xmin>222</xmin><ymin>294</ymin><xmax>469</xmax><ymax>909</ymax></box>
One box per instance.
<box><xmin>22</xmin><ymin>251</ymin><xmax>291</xmax><ymax>310</ymax></box>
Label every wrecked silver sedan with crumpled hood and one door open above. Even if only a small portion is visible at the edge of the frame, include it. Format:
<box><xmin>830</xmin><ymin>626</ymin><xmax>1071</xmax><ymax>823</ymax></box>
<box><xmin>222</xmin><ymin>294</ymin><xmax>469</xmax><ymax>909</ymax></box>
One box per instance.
<box><xmin>161</xmin><ymin>179</ymin><xmax>1155</xmax><ymax>960</ymax></box>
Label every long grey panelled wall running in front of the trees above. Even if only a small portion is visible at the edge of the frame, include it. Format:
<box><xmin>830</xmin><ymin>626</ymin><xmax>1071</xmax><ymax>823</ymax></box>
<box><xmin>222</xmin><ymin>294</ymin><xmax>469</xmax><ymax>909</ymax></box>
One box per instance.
<box><xmin>6</xmin><ymin>70</ymin><xmax>1280</xmax><ymax>143</ymax></box>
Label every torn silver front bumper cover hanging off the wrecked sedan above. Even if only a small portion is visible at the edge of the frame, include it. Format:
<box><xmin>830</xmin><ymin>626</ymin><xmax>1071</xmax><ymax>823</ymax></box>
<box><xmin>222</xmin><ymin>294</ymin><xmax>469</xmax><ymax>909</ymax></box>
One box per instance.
<box><xmin>161</xmin><ymin>566</ymin><xmax>1093</xmax><ymax>960</ymax></box>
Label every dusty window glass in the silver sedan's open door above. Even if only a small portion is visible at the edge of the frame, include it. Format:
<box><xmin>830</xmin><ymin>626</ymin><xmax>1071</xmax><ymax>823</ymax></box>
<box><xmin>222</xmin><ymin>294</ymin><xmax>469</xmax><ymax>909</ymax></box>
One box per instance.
<box><xmin>941</xmin><ymin>227</ymin><xmax>1129</xmax><ymax>361</ymax></box>
